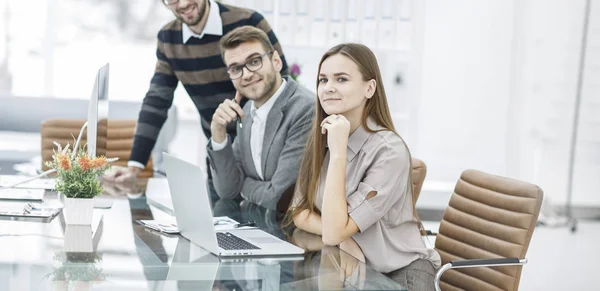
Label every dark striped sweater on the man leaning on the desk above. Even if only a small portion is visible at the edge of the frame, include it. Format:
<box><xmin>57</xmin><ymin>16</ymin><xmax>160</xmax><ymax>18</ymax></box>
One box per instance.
<box><xmin>129</xmin><ymin>3</ymin><xmax>288</xmax><ymax>165</ymax></box>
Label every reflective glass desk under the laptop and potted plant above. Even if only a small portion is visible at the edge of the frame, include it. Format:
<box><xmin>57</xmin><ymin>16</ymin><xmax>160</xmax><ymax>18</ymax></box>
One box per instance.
<box><xmin>0</xmin><ymin>181</ymin><xmax>405</xmax><ymax>291</ymax></box>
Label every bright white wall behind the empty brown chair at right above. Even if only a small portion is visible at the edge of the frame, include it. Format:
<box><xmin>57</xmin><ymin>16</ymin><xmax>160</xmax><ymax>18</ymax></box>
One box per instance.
<box><xmin>413</xmin><ymin>0</ymin><xmax>600</xmax><ymax>207</ymax></box>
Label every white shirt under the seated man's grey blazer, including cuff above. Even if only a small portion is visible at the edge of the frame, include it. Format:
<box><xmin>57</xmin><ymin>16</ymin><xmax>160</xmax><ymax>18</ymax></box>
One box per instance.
<box><xmin>210</xmin><ymin>79</ymin><xmax>287</xmax><ymax>180</ymax></box>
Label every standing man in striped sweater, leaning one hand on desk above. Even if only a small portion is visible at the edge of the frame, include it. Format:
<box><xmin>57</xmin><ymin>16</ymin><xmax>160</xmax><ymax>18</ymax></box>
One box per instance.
<box><xmin>104</xmin><ymin>0</ymin><xmax>288</xmax><ymax>186</ymax></box>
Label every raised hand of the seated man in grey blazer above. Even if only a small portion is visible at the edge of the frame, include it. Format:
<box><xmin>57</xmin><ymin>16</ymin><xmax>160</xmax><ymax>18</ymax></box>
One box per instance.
<box><xmin>210</xmin><ymin>92</ymin><xmax>245</xmax><ymax>143</ymax></box>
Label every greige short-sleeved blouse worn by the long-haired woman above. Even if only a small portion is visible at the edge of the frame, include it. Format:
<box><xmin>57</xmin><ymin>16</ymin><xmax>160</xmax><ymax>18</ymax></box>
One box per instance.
<box><xmin>295</xmin><ymin>118</ymin><xmax>441</xmax><ymax>273</ymax></box>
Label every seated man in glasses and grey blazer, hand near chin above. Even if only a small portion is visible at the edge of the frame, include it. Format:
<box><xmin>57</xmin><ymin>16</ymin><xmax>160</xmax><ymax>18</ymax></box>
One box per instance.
<box><xmin>207</xmin><ymin>26</ymin><xmax>316</xmax><ymax>209</ymax></box>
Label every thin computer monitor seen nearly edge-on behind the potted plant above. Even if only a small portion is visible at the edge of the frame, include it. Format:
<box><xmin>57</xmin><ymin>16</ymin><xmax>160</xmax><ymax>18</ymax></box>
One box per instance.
<box><xmin>87</xmin><ymin>64</ymin><xmax>109</xmax><ymax>157</ymax></box>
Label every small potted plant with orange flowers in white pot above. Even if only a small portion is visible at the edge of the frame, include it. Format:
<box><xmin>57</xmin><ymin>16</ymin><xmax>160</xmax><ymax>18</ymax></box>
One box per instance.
<box><xmin>46</xmin><ymin>142</ymin><xmax>117</xmax><ymax>225</ymax></box>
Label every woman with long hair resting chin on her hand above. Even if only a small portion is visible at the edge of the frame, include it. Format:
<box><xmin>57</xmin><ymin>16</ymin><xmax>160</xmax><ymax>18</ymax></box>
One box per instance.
<box><xmin>288</xmin><ymin>43</ymin><xmax>441</xmax><ymax>291</ymax></box>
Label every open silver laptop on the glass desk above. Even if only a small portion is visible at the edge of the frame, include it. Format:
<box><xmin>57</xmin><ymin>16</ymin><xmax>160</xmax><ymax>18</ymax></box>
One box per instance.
<box><xmin>163</xmin><ymin>153</ymin><xmax>304</xmax><ymax>257</ymax></box>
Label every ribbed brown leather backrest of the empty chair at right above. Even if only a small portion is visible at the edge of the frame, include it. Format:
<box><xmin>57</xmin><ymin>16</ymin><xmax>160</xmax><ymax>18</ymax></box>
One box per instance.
<box><xmin>435</xmin><ymin>170</ymin><xmax>543</xmax><ymax>291</ymax></box>
